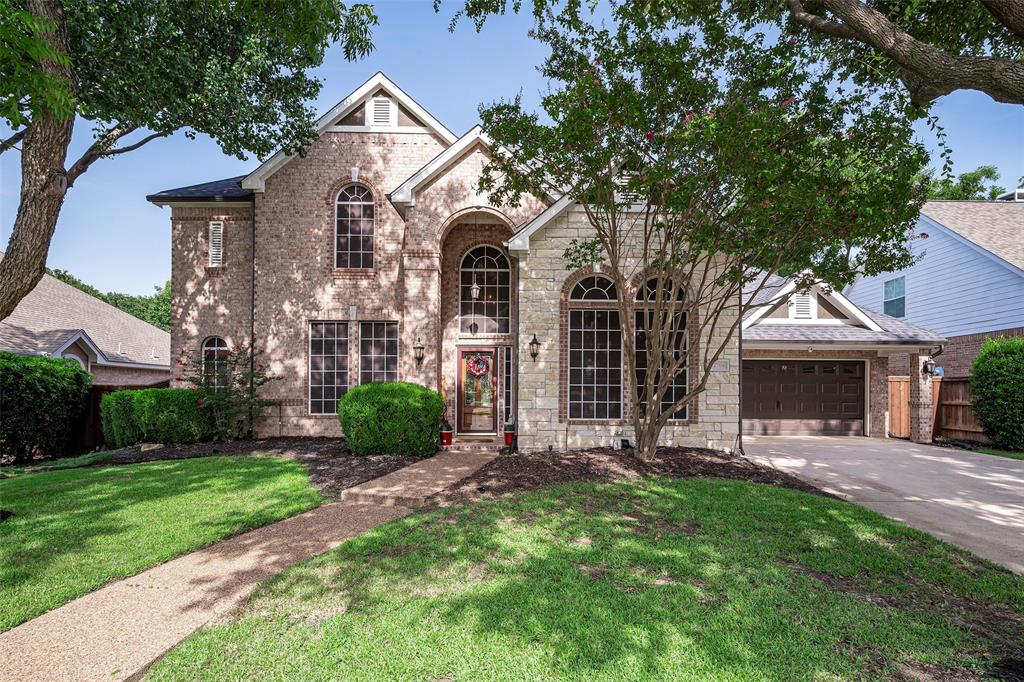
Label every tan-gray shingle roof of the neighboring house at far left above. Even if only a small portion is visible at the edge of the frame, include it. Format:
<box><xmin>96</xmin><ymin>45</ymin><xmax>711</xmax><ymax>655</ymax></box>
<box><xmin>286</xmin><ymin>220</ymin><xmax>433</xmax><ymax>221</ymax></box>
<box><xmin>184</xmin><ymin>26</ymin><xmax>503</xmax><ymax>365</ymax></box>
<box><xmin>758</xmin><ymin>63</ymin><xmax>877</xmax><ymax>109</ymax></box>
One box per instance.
<box><xmin>0</xmin><ymin>252</ymin><xmax>171</xmax><ymax>368</ymax></box>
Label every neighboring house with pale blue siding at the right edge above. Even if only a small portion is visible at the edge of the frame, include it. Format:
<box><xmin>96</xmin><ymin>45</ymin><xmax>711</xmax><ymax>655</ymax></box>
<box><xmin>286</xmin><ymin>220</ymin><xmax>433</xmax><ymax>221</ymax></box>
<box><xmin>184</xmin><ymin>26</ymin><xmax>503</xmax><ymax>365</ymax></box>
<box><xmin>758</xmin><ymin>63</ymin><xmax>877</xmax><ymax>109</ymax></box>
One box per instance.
<box><xmin>846</xmin><ymin>197</ymin><xmax>1024</xmax><ymax>377</ymax></box>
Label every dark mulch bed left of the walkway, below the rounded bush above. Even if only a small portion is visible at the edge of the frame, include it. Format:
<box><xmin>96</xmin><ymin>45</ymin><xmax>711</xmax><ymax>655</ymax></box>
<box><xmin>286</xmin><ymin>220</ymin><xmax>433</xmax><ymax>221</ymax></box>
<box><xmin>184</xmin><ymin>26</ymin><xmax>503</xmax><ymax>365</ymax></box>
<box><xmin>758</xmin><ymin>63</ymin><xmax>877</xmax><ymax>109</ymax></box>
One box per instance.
<box><xmin>104</xmin><ymin>437</ymin><xmax>418</xmax><ymax>498</ymax></box>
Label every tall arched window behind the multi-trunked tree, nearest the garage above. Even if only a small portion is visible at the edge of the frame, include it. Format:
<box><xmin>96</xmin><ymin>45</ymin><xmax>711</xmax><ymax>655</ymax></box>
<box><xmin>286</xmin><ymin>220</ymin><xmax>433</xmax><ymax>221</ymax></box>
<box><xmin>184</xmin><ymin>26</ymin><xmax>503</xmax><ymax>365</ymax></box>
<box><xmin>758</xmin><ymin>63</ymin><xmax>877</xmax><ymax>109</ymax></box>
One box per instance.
<box><xmin>634</xmin><ymin>278</ymin><xmax>689</xmax><ymax>420</ymax></box>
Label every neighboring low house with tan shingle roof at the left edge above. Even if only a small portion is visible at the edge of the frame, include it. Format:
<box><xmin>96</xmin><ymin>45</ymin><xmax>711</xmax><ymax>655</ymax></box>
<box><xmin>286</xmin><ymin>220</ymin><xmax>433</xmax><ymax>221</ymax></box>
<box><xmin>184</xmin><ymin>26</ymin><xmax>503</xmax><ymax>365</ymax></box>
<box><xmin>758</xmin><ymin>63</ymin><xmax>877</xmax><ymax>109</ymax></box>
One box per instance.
<box><xmin>0</xmin><ymin>253</ymin><xmax>171</xmax><ymax>386</ymax></box>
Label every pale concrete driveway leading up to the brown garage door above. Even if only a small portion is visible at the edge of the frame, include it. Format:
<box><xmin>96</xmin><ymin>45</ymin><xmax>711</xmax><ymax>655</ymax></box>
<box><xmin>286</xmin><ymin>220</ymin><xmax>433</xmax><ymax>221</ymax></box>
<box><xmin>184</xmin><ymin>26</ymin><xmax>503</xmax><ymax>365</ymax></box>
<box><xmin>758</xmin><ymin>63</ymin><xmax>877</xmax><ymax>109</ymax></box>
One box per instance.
<box><xmin>743</xmin><ymin>436</ymin><xmax>1024</xmax><ymax>573</ymax></box>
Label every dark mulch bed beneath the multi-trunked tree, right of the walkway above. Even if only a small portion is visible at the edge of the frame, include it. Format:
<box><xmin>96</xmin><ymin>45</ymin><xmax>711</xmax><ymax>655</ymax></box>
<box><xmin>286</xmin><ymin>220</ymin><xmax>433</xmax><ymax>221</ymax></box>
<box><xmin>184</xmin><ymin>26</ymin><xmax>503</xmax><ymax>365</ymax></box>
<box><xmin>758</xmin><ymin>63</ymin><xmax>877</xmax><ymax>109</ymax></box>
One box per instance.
<box><xmin>437</xmin><ymin>447</ymin><xmax>835</xmax><ymax>500</ymax></box>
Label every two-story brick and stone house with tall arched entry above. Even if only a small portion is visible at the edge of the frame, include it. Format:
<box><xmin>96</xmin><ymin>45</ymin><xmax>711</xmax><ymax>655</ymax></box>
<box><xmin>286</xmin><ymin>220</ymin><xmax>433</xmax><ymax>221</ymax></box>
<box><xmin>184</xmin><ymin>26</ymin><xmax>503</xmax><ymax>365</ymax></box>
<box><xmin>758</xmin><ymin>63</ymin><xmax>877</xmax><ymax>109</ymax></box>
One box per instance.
<box><xmin>147</xmin><ymin>74</ymin><xmax>942</xmax><ymax>450</ymax></box>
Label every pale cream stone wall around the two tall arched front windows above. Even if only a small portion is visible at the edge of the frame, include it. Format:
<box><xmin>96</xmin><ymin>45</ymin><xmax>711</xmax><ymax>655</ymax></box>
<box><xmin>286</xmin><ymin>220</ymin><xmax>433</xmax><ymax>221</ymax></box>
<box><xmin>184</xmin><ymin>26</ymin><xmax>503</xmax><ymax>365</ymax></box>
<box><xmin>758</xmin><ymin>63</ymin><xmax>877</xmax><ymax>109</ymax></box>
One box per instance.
<box><xmin>516</xmin><ymin>209</ymin><xmax>739</xmax><ymax>451</ymax></box>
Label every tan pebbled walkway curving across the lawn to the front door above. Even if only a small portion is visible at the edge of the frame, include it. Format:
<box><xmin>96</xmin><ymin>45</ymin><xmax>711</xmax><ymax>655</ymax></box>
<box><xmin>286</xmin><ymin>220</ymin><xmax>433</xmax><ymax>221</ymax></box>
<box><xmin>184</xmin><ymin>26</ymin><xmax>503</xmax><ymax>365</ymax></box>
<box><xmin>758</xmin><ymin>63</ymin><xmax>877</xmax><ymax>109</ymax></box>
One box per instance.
<box><xmin>0</xmin><ymin>453</ymin><xmax>495</xmax><ymax>682</ymax></box>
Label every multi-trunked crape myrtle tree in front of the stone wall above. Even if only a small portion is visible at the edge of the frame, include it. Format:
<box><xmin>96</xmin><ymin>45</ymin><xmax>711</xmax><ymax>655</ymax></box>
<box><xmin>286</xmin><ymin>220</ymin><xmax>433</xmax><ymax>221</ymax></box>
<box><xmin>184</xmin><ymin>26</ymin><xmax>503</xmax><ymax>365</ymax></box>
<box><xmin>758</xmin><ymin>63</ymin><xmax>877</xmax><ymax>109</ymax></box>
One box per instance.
<box><xmin>480</xmin><ymin>3</ymin><xmax>928</xmax><ymax>457</ymax></box>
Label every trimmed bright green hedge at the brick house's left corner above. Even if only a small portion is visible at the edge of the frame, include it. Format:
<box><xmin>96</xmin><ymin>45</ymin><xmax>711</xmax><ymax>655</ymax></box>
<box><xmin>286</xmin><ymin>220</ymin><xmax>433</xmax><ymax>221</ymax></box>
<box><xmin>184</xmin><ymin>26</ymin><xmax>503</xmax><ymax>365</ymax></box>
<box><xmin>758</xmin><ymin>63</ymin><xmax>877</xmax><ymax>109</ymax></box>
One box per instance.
<box><xmin>99</xmin><ymin>388</ymin><xmax>214</xmax><ymax>447</ymax></box>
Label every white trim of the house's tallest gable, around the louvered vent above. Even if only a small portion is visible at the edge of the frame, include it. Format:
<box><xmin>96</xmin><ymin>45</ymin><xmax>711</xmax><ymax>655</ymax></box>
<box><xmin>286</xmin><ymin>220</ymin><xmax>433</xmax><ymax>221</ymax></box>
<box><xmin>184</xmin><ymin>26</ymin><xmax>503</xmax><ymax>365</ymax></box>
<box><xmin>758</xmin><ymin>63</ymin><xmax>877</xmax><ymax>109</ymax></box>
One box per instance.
<box><xmin>242</xmin><ymin>72</ymin><xmax>457</xmax><ymax>191</ymax></box>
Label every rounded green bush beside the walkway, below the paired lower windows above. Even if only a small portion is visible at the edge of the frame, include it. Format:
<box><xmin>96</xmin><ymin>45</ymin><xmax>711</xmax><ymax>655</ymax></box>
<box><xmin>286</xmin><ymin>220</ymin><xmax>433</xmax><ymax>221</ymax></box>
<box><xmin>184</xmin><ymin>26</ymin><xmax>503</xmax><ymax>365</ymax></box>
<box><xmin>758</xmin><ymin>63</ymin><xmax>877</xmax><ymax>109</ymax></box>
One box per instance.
<box><xmin>338</xmin><ymin>382</ymin><xmax>444</xmax><ymax>457</ymax></box>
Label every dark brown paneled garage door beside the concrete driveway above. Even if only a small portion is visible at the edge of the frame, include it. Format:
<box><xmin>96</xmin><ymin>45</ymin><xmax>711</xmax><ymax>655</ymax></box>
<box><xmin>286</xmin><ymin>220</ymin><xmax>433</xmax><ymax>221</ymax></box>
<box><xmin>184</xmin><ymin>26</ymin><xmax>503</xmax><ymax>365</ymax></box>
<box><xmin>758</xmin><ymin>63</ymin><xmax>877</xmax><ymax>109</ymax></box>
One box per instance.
<box><xmin>742</xmin><ymin>360</ymin><xmax>864</xmax><ymax>435</ymax></box>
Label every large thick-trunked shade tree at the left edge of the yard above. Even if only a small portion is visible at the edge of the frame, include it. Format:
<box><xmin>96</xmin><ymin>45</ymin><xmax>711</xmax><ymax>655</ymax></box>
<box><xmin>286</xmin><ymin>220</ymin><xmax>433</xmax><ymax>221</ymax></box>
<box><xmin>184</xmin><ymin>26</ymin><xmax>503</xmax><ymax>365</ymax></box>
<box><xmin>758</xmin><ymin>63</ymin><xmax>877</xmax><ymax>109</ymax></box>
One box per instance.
<box><xmin>0</xmin><ymin>0</ymin><xmax>377</xmax><ymax>319</ymax></box>
